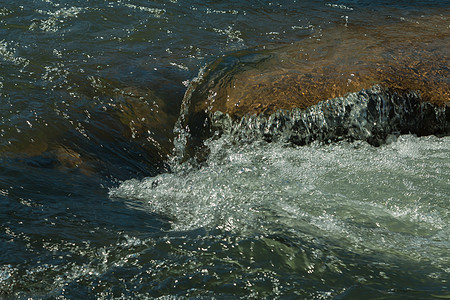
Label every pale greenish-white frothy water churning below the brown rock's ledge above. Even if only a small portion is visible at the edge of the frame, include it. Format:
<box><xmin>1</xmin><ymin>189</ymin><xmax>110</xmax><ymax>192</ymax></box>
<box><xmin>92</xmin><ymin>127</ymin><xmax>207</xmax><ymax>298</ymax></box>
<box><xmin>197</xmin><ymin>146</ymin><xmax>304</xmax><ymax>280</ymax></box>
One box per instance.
<box><xmin>110</xmin><ymin>136</ymin><xmax>450</xmax><ymax>265</ymax></box>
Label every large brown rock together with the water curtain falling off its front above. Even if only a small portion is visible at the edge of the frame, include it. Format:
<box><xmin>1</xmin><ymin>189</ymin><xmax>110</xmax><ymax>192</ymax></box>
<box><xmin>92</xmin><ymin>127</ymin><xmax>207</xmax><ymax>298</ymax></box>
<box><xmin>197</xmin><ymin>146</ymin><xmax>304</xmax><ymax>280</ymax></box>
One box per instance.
<box><xmin>176</xmin><ymin>16</ymin><xmax>450</xmax><ymax>162</ymax></box>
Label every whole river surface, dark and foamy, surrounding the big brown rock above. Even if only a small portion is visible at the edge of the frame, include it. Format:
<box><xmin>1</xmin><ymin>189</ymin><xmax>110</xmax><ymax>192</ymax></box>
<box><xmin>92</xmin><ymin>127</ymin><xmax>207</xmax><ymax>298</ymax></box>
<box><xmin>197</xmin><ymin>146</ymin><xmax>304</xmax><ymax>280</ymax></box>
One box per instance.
<box><xmin>0</xmin><ymin>0</ymin><xmax>450</xmax><ymax>299</ymax></box>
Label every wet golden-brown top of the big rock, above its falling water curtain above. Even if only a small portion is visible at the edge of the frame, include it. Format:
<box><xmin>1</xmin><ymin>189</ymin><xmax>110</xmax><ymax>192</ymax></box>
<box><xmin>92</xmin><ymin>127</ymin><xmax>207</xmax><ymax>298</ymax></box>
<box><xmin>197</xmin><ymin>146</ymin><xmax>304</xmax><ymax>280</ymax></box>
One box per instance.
<box><xmin>185</xmin><ymin>15</ymin><xmax>450</xmax><ymax>119</ymax></box>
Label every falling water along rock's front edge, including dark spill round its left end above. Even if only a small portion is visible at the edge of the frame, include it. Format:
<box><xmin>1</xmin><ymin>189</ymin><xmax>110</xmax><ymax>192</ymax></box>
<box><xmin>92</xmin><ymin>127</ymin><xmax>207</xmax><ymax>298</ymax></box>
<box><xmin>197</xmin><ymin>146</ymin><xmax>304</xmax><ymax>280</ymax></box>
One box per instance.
<box><xmin>175</xmin><ymin>85</ymin><xmax>450</xmax><ymax>165</ymax></box>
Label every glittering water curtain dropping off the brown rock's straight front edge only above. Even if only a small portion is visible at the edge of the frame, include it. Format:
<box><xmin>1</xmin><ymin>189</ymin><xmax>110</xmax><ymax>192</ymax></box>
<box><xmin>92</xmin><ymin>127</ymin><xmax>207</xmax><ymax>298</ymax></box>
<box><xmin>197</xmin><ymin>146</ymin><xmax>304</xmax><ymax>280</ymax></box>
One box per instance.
<box><xmin>210</xmin><ymin>86</ymin><xmax>450</xmax><ymax>145</ymax></box>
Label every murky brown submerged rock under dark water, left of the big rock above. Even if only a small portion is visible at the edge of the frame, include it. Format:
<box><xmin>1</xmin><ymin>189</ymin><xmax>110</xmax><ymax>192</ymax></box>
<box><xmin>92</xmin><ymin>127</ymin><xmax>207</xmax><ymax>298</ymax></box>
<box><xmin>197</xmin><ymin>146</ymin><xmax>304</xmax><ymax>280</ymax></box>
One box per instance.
<box><xmin>0</xmin><ymin>79</ymin><xmax>178</xmax><ymax>178</ymax></box>
